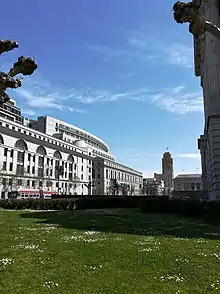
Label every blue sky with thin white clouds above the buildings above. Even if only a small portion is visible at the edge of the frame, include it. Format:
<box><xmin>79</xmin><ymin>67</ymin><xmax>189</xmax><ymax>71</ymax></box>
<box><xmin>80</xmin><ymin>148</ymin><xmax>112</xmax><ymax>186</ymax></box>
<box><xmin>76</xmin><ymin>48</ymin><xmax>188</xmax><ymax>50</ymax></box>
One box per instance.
<box><xmin>0</xmin><ymin>0</ymin><xmax>203</xmax><ymax>176</ymax></box>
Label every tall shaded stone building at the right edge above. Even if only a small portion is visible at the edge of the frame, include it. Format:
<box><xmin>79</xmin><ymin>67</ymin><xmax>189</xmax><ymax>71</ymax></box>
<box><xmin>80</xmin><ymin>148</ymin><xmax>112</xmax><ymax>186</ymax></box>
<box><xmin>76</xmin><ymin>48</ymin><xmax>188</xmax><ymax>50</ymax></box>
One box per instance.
<box><xmin>193</xmin><ymin>0</ymin><xmax>220</xmax><ymax>201</ymax></box>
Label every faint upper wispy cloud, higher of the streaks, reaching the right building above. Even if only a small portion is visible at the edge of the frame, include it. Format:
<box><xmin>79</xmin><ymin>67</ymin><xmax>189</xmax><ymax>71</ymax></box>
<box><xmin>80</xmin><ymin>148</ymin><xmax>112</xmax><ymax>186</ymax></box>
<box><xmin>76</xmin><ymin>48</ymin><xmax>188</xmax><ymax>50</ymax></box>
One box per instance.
<box><xmin>88</xmin><ymin>31</ymin><xmax>193</xmax><ymax>68</ymax></box>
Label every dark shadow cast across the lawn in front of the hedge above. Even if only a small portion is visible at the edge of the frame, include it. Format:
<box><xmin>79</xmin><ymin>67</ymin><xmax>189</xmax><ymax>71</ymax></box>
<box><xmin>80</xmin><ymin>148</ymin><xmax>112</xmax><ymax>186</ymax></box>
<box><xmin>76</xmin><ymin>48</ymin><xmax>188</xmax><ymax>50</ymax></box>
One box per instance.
<box><xmin>20</xmin><ymin>209</ymin><xmax>220</xmax><ymax>240</ymax></box>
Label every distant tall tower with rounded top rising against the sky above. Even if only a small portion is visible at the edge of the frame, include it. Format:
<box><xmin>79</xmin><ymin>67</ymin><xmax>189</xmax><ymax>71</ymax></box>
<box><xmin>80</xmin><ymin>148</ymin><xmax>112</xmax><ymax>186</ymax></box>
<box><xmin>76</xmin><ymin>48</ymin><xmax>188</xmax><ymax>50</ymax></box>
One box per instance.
<box><xmin>162</xmin><ymin>152</ymin><xmax>173</xmax><ymax>189</ymax></box>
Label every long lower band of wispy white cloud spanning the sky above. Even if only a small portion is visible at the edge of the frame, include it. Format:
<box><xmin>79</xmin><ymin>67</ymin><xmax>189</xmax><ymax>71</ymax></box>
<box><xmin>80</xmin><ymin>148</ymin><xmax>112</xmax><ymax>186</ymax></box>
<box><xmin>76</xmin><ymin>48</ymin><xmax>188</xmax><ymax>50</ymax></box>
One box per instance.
<box><xmin>12</xmin><ymin>73</ymin><xmax>203</xmax><ymax>114</ymax></box>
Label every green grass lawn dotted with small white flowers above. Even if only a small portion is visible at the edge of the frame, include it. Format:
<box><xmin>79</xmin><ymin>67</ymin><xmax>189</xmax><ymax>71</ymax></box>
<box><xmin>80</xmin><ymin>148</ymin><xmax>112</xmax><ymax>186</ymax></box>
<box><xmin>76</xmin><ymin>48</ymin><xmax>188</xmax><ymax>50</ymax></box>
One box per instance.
<box><xmin>0</xmin><ymin>209</ymin><xmax>220</xmax><ymax>294</ymax></box>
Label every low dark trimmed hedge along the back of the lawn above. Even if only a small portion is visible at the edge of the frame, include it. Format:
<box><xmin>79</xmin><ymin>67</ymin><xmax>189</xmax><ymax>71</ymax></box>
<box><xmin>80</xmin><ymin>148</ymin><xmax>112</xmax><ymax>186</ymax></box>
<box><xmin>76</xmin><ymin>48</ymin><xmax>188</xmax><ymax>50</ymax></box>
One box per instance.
<box><xmin>0</xmin><ymin>197</ymin><xmax>220</xmax><ymax>222</ymax></box>
